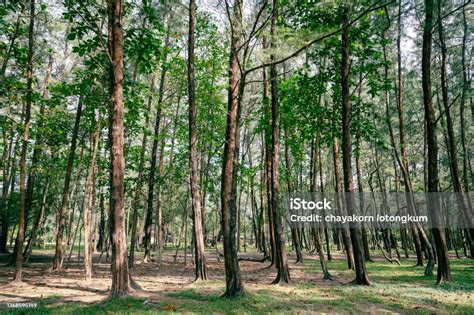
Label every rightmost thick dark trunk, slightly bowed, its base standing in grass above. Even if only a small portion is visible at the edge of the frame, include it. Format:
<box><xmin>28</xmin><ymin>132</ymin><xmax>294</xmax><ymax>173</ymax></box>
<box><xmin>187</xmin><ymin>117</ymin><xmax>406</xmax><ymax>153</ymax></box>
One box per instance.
<box><xmin>421</xmin><ymin>0</ymin><xmax>451</xmax><ymax>284</ymax></box>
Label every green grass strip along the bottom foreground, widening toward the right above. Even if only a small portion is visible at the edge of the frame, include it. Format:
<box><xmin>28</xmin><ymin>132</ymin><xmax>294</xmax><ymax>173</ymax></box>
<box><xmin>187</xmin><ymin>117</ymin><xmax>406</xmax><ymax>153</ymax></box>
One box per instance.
<box><xmin>3</xmin><ymin>259</ymin><xmax>474</xmax><ymax>315</ymax></box>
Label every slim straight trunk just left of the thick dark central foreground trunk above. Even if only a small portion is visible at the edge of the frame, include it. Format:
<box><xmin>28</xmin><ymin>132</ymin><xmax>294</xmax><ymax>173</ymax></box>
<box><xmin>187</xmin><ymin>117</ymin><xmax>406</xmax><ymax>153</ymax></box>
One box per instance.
<box><xmin>188</xmin><ymin>0</ymin><xmax>207</xmax><ymax>280</ymax></box>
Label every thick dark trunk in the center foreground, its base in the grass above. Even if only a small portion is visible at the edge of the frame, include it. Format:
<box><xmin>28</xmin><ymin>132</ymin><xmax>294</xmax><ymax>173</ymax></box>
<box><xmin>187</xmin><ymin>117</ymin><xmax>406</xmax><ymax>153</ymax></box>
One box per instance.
<box><xmin>221</xmin><ymin>0</ymin><xmax>244</xmax><ymax>297</ymax></box>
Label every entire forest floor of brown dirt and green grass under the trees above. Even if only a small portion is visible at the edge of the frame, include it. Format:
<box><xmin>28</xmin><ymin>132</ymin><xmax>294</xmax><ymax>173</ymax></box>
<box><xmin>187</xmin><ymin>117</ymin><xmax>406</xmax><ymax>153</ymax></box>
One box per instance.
<box><xmin>0</xmin><ymin>250</ymin><xmax>474</xmax><ymax>314</ymax></box>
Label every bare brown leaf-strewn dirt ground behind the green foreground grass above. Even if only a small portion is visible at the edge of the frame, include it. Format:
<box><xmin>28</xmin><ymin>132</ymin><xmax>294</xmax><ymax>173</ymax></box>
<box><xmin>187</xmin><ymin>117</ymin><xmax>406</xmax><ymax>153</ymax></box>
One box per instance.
<box><xmin>0</xmin><ymin>251</ymin><xmax>336</xmax><ymax>303</ymax></box>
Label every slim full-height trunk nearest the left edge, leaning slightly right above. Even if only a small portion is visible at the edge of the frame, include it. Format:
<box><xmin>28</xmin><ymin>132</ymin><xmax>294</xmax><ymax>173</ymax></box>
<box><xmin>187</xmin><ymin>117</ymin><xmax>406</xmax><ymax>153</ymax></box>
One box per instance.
<box><xmin>14</xmin><ymin>0</ymin><xmax>35</xmax><ymax>282</ymax></box>
